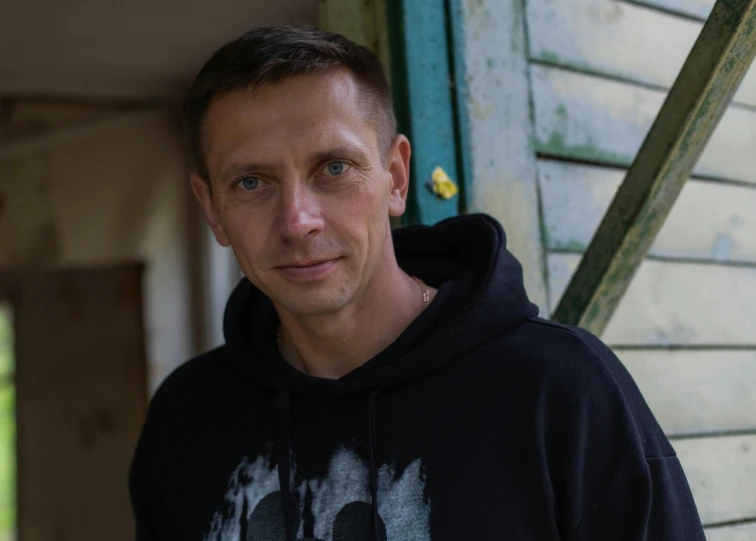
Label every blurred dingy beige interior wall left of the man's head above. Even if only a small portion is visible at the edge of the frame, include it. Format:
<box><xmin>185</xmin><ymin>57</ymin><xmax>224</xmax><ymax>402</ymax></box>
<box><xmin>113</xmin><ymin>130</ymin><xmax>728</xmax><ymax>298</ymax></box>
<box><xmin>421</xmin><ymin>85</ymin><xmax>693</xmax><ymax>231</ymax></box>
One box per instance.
<box><xmin>0</xmin><ymin>101</ymin><xmax>198</xmax><ymax>390</ymax></box>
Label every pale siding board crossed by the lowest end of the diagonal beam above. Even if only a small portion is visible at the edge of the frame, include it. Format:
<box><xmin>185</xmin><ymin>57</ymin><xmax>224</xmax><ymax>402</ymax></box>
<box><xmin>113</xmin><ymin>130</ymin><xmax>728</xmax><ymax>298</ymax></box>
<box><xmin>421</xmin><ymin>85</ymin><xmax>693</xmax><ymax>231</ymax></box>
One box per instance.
<box><xmin>548</xmin><ymin>253</ymin><xmax>756</xmax><ymax>346</ymax></box>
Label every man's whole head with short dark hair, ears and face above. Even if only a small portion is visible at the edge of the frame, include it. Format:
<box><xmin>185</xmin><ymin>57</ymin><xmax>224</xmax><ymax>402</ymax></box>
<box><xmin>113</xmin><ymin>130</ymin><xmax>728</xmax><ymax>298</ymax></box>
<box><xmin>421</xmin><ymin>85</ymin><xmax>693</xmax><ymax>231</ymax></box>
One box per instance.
<box><xmin>184</xmin><ymin>26</ymin><xmax>410</xmax><ymax>315</ymax></box>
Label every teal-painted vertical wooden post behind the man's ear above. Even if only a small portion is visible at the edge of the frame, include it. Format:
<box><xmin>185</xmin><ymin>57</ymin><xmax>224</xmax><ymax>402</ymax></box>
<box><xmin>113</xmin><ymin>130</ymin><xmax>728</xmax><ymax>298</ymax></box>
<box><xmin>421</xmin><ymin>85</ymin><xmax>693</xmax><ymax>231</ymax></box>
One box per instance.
<box><xmin>386</xmin><ymin>0</ymin><xmax>460</xmax><ymax>224</ymax></box>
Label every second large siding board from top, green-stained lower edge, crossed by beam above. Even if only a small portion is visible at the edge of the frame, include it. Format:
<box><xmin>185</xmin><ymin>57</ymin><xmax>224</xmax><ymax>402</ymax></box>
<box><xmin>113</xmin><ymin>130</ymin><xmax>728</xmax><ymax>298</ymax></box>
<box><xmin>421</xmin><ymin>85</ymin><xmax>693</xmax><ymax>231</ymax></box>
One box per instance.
<box><xmin>531</xmin><ymin>65</ymin><xmax>756</xmax><ymax>183</ymax></box>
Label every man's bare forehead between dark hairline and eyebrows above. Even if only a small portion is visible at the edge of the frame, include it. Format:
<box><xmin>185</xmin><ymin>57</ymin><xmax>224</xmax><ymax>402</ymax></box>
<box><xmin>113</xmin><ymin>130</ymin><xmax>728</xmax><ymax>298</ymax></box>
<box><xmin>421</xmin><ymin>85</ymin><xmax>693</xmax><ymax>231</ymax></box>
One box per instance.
<box><xmin>204</xmin><ymin>71</ymin><xmax>377</xmax><ymax>171</ymax></box>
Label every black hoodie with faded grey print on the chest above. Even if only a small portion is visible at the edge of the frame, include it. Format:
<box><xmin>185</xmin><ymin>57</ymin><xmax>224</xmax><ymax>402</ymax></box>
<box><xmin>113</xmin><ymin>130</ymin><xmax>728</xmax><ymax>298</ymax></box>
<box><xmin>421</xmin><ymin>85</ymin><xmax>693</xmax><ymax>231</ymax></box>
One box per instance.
<box><xmin>130</xmin><ymin>215</ymin><xmax>704</xmax><ymax>541</ymax></box>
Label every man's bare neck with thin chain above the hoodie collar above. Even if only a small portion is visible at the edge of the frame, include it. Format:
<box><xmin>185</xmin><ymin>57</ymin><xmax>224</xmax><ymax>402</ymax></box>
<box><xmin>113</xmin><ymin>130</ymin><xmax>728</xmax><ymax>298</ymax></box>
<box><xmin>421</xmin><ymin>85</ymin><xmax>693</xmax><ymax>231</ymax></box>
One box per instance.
<box><xmin>279</xmin><ymin>249</ymin><xmax>436</xmax><ymax>379</ymax></box>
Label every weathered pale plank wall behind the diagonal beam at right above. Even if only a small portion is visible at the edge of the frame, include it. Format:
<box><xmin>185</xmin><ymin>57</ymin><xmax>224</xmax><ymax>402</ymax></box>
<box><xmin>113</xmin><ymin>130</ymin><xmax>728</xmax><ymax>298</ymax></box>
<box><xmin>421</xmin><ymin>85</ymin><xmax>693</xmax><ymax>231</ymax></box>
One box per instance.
<box><xmin>454</xmin><ymin>0</ymin><xmax>756</xmax><ymax>541</ymax></box>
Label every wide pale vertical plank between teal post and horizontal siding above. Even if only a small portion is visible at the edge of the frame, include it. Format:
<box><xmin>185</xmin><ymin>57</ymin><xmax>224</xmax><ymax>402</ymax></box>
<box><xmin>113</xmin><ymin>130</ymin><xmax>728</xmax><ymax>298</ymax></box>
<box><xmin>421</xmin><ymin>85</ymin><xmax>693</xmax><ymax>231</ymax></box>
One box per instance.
<box><xmin>463</xmin><ymin>0</ymin><xmax>547</xmax><ymax>313</ymax></box>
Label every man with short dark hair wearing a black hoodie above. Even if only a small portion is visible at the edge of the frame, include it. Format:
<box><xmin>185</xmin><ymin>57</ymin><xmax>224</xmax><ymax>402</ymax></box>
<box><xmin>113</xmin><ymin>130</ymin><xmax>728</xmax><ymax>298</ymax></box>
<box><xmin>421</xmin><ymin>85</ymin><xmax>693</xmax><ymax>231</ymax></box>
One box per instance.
<box><xmin>130</xmin><ymin>27</ymin><xmax>704</xmax><ymax>541</ymax></box>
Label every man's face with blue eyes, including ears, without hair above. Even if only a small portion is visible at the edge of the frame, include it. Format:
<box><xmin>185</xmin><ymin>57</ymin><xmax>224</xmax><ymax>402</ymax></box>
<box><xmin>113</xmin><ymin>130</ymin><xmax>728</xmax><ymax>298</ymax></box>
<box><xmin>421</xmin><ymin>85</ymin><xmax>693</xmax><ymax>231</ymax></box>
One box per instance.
<box><xmin>192</xmin><ymin>71</ymin><xmax>410</xmax><ymax>315</ymax></box>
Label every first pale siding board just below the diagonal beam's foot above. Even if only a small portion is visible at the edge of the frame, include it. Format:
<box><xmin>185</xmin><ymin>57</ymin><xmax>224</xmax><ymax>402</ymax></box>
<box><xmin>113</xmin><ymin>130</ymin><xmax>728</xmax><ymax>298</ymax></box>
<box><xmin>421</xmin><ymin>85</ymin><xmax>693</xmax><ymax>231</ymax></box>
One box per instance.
<box><xmin>615</xmin><ymin>349</ymin><xmax>756</xmax><ymax>436</ymax></box>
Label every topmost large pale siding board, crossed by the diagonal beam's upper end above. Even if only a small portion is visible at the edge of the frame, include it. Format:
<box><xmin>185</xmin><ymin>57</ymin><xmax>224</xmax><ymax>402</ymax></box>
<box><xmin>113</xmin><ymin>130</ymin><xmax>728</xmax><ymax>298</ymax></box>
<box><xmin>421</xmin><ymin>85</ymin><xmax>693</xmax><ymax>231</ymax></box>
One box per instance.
<box><xmin>527</xmin><ymin>0</ymin><xmax>756</xmax><ymax>105</ymax></box>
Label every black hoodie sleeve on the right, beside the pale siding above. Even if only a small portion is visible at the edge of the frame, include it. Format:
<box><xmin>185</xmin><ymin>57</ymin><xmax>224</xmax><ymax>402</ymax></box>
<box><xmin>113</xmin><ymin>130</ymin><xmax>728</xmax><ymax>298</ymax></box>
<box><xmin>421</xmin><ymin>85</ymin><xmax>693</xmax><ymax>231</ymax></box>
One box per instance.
<box><xmin>545</xmin><ymin>327</ymin><xmax>705</xmax><ymax>541</ymax></box>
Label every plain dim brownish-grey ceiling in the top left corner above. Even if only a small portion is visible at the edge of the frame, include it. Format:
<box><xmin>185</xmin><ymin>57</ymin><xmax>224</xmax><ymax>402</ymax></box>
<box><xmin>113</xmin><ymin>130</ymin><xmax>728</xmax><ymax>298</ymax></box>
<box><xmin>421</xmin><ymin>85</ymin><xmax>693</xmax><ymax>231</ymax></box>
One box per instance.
<box><xmin>0</xmin><ymin>0</ymin><xmax>318</xmax><ymax>100</ymax></box>
